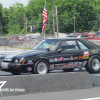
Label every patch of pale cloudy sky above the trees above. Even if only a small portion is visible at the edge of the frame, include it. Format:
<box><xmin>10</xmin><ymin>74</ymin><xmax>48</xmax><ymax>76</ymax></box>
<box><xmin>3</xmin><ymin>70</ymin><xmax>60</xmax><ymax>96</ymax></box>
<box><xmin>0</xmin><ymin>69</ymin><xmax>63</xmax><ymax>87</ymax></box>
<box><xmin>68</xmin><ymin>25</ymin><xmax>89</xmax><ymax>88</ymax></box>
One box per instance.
<box><xmin>0</xmin><ymin>0</ymin><xmax>29</xmax><ymax>8</ymax></box>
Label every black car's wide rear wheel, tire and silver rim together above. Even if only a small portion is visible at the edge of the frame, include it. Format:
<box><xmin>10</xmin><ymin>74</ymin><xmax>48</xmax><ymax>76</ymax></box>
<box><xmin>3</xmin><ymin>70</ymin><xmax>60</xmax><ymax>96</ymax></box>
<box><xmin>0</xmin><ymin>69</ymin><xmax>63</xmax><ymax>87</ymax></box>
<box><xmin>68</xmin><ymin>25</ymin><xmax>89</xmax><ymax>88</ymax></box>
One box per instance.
<box><xmin>85</xmin><ymin>55</ymin><xmax>100</xmax><ymax>74</ymax></box>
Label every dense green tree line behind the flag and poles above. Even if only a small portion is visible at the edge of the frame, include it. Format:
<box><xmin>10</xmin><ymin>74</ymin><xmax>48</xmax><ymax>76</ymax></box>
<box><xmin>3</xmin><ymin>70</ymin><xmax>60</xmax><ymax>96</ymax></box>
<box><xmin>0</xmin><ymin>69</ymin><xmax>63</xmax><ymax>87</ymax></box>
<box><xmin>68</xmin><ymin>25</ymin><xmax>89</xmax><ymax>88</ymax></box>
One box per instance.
<box><xmin>0</xmin><ymin>0</ymin><xmax>100</xmax><ymax>34</ymax></box>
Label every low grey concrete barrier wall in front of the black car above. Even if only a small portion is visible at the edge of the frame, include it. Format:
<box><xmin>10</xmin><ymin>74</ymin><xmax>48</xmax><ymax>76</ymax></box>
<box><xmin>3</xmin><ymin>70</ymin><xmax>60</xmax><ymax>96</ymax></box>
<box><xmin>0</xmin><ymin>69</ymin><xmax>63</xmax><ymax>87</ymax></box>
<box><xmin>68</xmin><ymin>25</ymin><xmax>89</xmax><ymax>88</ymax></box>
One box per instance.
<box><xmin>0</xmin><ymin>72</ymin><xmax>93</xmax><ymax>97</ymax></box>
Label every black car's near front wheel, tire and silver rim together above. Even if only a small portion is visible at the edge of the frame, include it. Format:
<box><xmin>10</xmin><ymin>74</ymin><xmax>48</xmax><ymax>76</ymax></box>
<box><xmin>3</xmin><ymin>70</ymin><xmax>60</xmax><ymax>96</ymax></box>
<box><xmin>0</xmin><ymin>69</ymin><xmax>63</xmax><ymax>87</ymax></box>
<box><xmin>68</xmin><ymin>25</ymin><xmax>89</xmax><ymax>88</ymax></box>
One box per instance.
<box><xmin>33</xmin><ymin>60</ymin><xmax>49</xmax><ymax>74</ymax></box>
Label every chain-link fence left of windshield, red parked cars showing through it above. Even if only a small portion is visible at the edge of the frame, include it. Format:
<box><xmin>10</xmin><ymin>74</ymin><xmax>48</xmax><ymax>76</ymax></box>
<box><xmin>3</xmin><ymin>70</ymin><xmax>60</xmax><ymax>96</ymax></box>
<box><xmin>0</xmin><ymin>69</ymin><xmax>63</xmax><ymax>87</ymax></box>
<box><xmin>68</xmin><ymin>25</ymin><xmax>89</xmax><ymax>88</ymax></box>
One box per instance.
<box><xmin>0</xmin><ymin>34</ymin><xmax>43</xmax><ymax>50</ymax></box>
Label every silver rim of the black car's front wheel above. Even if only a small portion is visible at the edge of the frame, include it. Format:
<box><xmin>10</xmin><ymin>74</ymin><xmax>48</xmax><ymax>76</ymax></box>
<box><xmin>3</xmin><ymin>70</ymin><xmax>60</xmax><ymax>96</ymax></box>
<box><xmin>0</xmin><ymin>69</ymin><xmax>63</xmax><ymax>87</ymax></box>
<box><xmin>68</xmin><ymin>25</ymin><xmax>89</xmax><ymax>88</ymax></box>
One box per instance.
<box><xmin>37</xmin><ymin>62</ymin><xmax>47</xmax><ymax>74</ymax></box>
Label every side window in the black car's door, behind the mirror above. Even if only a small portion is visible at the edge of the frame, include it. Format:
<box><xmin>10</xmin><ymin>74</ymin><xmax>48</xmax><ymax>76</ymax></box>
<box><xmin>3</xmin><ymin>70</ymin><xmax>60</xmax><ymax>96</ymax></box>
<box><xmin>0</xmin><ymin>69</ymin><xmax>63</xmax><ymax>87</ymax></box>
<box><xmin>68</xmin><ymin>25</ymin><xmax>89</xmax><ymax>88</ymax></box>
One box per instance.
<box><xmin>59</xmin><ymin>40</ymin><xmax>78</xmax><ymax>51</ymax></box>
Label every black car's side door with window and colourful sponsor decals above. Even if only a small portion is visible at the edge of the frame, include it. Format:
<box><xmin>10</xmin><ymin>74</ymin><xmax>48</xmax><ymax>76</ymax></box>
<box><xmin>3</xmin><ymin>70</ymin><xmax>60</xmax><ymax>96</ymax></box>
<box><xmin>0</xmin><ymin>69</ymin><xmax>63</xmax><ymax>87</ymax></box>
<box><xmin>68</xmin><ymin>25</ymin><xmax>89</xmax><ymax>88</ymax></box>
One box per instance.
<box><xmin>54</xmin><ymin>40</ymin><xmax>84</xmax><ymax>69</ymax></box>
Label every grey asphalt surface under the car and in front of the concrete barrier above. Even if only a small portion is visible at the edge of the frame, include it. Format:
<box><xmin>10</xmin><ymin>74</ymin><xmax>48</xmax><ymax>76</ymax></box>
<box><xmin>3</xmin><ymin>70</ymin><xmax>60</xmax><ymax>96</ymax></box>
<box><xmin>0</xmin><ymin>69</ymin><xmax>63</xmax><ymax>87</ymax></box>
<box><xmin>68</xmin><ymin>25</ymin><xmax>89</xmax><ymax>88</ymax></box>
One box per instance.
<box><xmin>0</xmin><ymin>69</ymin><xmax>100</xmax><ymax>100</ymax></box>
